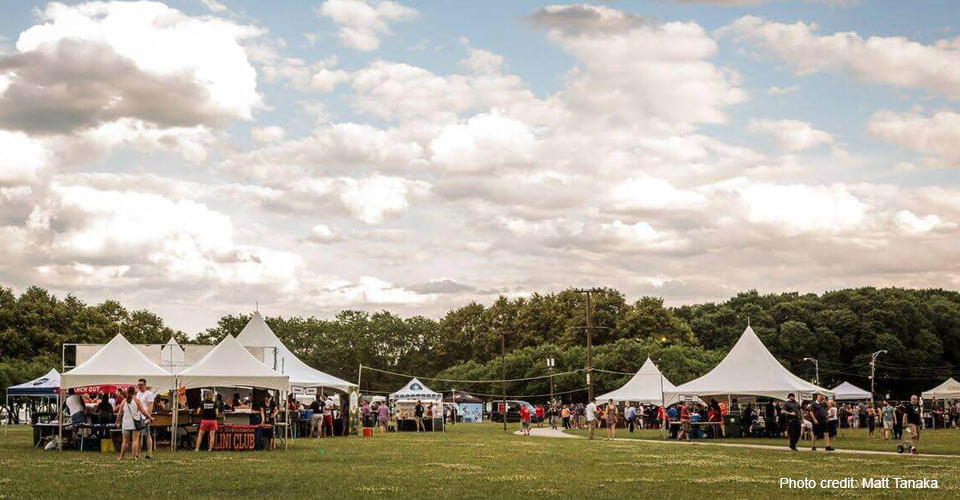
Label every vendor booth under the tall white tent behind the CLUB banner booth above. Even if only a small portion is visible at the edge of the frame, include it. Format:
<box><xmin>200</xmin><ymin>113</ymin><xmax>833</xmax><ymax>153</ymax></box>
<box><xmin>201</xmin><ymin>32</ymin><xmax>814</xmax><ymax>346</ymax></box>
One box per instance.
<box><xmin>237</xmin><ymin>311</ymin><xmax>357</xmax><ymax>436</ymax></box>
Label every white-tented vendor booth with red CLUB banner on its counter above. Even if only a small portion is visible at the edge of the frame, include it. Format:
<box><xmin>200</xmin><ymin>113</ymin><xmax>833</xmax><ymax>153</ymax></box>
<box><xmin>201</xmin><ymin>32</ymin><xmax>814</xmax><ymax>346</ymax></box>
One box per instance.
<box><xmin>174</xmin><ymin>335</ymin><xmax>290</xmax><ymax>450</ymax></box>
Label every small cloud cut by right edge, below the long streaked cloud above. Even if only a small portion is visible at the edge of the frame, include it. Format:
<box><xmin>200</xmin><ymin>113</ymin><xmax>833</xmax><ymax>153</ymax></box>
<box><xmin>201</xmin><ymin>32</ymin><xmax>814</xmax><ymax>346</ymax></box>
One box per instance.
<box><xmin>867</xmin><ymin>111</ymin><xmax>960</xmax><ymax>167</ymax></box>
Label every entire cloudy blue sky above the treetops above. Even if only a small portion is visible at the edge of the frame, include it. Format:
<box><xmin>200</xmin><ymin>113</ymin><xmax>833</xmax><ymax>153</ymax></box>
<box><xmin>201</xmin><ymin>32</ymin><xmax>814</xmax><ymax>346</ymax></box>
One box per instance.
<box><xmin>0</xmin><ymin>0</ymin><xmax>960</xmax><ymax>333</ymax></box>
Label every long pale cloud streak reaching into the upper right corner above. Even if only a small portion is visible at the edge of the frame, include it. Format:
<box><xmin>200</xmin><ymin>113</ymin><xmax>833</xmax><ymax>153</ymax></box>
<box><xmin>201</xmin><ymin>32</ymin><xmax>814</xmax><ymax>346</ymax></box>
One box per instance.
<box><xmin>719</xmin><ymin>16</ymin><xmax>960</xmax><ymax>100</ymax></box>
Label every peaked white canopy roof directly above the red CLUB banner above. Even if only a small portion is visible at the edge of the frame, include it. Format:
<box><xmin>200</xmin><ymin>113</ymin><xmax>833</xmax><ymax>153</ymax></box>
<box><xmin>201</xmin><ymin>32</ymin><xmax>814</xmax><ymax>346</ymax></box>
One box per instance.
<box><xmin>178</xmin><ymin>335</ymin><xmax>290</xmax><ymax>391</ymax></box>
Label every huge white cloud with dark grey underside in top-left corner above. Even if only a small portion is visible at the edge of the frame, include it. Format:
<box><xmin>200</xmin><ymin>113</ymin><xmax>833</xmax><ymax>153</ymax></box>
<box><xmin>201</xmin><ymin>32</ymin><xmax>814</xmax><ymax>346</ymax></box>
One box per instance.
<box><xmin>0</xmin><ymin>2</ymin><xmax>261</xmax><ymax>132</ymax></box>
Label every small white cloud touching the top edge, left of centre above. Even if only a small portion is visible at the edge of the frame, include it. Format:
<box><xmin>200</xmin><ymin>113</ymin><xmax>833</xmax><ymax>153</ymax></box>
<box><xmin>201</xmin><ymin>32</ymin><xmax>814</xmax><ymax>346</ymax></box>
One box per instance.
<box><xmin>317</xmin><ymin>0</ymin><xmax>419</xmax><ymax>52</ymax></box>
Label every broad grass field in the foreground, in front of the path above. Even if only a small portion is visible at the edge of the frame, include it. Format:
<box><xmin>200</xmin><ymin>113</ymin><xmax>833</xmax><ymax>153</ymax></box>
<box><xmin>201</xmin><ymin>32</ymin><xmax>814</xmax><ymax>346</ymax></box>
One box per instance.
<box><xmin>0</xmin><ymin>424</ymin><xmax>960</xmax><ymax>499</ymax></box>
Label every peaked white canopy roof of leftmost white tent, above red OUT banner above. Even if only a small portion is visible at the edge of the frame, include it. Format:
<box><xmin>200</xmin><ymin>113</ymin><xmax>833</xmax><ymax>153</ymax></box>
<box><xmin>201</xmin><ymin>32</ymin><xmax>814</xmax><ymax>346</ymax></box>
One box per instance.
<box><xmin>61</xmin><ymin>333</ymin><xmax>174</xmax><ymax>391</ymax></box>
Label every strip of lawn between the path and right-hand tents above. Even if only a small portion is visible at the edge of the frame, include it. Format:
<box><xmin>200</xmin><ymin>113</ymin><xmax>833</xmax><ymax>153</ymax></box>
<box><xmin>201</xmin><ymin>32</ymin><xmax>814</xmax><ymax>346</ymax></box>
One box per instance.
<box><xmin>567</xmin><ymin>429</ymin><xmax>960</xmax><ymax>455</ymax></box>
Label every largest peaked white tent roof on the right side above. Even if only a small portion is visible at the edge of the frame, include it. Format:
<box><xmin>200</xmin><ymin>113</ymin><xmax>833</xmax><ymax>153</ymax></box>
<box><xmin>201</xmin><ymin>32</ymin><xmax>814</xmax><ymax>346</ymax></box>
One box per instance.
<box><xmin>669</xmin><ymin>325</ymin><xmax>832</xmax><ymax>400</ymax></box>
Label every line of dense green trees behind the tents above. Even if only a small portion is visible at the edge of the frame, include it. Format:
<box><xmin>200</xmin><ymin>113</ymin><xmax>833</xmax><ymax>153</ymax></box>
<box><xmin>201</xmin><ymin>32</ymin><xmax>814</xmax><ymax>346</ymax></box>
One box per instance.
<box><xmin>0</xmin><ymin>287</ymin><xmax>960</xmax><ymax>400</ymax></box>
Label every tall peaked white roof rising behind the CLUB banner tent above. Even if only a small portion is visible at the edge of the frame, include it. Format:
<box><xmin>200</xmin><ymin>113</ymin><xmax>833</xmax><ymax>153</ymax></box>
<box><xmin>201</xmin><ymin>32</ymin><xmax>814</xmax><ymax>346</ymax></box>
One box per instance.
<box><xmin>237</xmin><ymin>311</ymin><xmax>357</xmax><ymax>392</ymax></box>
